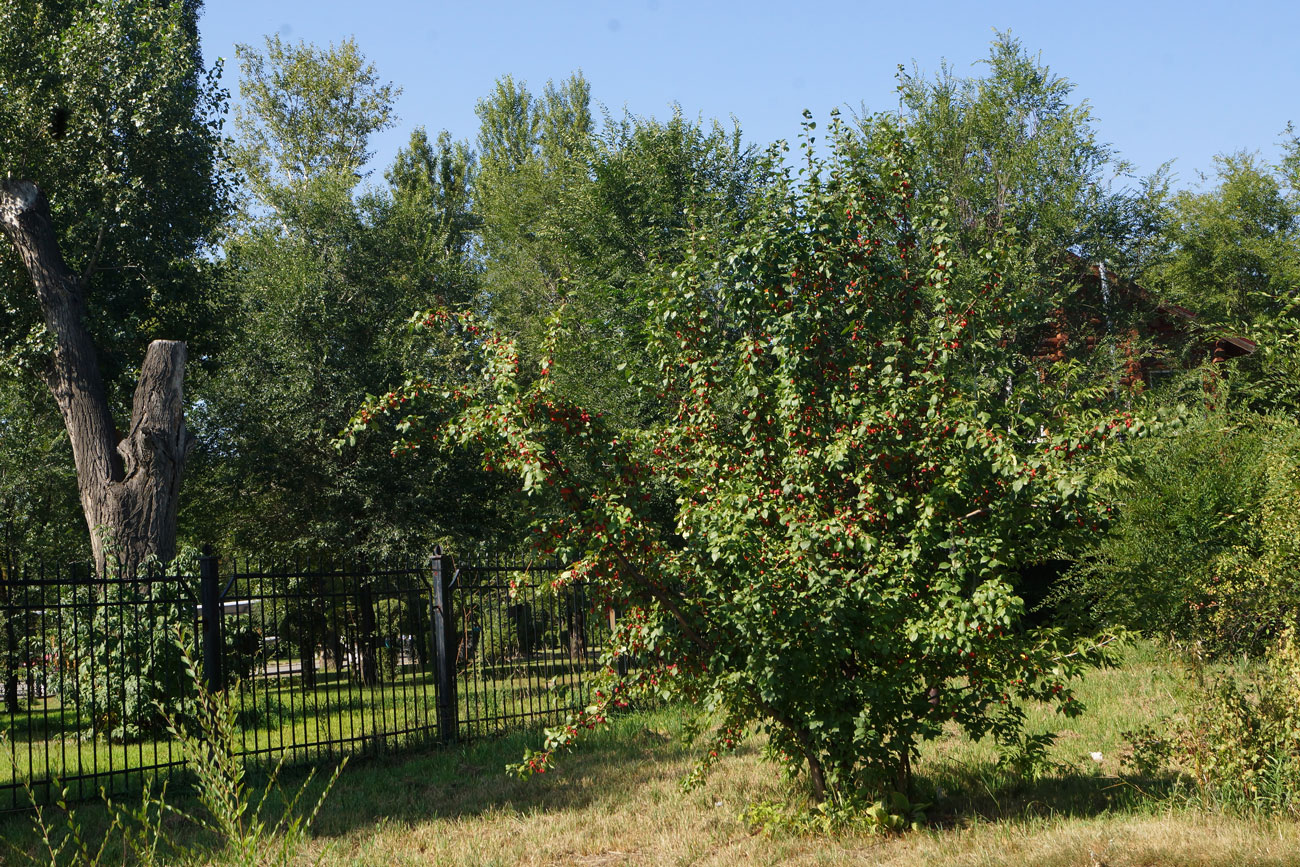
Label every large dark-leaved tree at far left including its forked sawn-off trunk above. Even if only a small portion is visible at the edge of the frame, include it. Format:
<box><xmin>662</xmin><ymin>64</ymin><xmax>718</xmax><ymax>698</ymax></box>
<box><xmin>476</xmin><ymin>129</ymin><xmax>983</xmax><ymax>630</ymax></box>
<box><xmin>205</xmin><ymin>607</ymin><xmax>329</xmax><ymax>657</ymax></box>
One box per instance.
<box><xmin>0</xmin><ymin>0</ymin><xmax>225</xmax><ymax>567</ymax></box>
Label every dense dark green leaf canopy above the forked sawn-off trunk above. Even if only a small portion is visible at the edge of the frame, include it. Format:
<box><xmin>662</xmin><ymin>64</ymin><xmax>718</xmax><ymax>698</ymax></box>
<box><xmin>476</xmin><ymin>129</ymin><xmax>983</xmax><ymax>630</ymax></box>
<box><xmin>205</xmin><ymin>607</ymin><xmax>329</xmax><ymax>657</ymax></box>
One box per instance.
<box><xmin>0</xmin><ymin>0</ymin><xmax>229</xmax><ymax>392</ymax></box>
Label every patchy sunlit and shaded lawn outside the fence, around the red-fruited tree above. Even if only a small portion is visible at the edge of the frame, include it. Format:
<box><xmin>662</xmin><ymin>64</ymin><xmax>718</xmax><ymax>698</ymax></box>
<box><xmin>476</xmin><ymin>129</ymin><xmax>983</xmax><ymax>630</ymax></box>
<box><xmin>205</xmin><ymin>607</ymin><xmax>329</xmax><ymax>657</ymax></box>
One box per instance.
<box><xmin>0</xmin><ymin>647</ymin><xmax>1300</xmax><ymax>867</ymax></box>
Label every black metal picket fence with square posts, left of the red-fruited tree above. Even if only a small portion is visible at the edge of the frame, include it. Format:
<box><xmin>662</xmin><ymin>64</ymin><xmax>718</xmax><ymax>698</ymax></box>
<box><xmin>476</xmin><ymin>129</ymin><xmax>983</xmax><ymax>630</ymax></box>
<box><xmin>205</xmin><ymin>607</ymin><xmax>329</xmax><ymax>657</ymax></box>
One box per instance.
<box><xmin>0</xmin><ymin>555</ymin><xmax>605</xmax><ymax>811</ymax></box>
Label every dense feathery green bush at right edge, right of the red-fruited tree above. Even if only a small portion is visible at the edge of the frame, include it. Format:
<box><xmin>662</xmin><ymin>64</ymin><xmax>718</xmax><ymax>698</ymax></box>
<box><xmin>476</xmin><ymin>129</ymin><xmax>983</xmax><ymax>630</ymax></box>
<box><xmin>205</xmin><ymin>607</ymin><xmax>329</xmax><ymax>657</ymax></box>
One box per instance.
<box><xmin>1069</xmin><ymin>415</ymin><xmax>1300</xmax><ymax>655</ymax></box>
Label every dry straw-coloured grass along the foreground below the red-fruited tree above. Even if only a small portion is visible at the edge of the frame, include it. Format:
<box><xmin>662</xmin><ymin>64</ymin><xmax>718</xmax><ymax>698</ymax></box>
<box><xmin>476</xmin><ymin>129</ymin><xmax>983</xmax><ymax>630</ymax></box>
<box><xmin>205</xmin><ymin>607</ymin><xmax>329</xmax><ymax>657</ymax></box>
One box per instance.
<box><xmin>295</xmin><ymin>714</ymin><xmax>1300</xmax><ymax>867</ymax></box>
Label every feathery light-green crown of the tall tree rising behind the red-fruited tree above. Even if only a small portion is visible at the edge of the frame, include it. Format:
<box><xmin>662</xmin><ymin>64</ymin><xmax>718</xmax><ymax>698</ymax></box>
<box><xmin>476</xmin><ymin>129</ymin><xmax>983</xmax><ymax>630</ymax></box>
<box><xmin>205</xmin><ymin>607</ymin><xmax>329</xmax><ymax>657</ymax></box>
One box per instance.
<box><xmin>898</xmin><ymin>32</ymin><xmax>1139</xmax><ymax>271</ymax></box>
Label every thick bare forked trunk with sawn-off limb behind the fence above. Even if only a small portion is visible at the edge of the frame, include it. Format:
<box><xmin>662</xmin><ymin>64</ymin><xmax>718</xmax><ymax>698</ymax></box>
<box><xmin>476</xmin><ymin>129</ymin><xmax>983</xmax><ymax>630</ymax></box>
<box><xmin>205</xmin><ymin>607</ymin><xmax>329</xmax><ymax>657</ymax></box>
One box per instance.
<box><xmin>0</xmin><ymin>179</ymin><xmax>192</xmax><ymax>575</ymax></box>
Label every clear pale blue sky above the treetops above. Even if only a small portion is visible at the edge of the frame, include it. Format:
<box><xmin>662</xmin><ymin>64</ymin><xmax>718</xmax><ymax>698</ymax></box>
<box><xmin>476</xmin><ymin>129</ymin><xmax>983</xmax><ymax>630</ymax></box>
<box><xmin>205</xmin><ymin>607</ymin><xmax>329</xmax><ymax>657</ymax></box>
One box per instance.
<box><xmin>200</xmin><ymin>0</ymin><xmax>1300</xmax><ymax>186</ymax></box>
